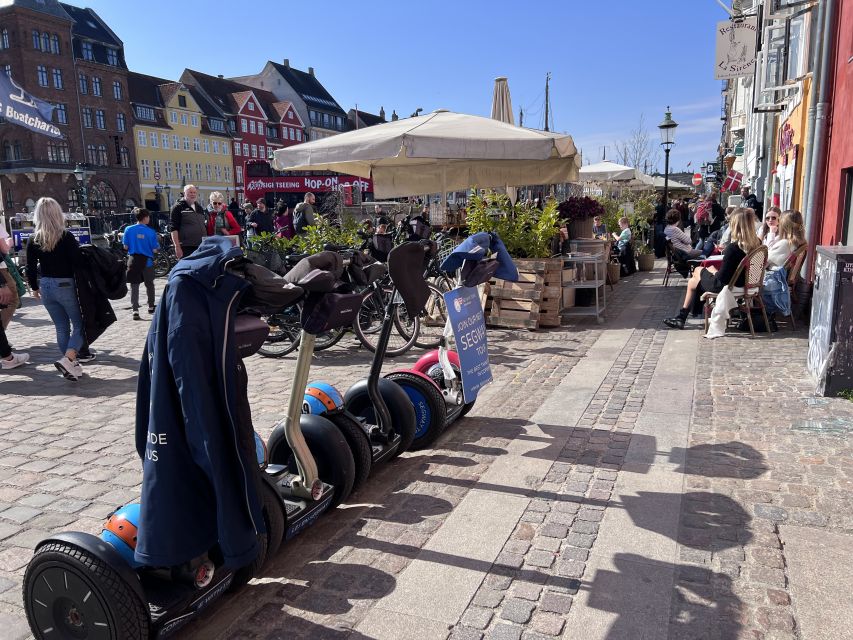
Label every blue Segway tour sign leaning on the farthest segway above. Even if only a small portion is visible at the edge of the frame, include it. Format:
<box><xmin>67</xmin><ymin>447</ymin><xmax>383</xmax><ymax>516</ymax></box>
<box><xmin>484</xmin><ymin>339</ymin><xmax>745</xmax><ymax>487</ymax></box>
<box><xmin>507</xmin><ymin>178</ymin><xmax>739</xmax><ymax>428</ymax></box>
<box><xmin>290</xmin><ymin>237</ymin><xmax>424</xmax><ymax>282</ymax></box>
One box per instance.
<box><xmin>444</xmin><ymin>287</ymin><xmax>492</xmax><ymax>404</ymax></box>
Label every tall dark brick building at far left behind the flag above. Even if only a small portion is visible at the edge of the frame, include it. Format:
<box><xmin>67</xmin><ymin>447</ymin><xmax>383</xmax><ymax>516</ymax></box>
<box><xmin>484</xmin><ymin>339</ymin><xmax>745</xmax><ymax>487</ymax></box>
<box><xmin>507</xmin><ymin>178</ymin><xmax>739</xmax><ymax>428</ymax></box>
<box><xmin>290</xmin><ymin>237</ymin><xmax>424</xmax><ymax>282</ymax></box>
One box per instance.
<box><xmin>0</xmin><ymin>0</ymin><xmax>139</xmax><ymax>212</ymax></box>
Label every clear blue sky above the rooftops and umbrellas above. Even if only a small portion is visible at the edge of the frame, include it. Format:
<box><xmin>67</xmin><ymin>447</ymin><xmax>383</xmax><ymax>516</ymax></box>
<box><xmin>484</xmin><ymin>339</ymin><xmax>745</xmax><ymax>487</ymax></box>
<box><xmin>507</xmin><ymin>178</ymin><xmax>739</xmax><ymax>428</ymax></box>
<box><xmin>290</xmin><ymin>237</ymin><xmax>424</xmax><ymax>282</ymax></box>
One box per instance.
<box><xmin>85</xmin><ymin>0</ymin><xmax>727</xmax><ymax>170</ymax></box>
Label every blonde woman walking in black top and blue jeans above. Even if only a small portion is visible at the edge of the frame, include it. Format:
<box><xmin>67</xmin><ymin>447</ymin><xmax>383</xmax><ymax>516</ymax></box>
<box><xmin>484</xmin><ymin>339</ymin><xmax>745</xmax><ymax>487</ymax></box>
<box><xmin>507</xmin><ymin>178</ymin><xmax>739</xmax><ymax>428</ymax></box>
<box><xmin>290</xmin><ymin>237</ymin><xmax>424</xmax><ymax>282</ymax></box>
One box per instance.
<box><xmin>27</xmin><ymin>198</ymin><xmax>83</xmax><ymax>381</ymax></box>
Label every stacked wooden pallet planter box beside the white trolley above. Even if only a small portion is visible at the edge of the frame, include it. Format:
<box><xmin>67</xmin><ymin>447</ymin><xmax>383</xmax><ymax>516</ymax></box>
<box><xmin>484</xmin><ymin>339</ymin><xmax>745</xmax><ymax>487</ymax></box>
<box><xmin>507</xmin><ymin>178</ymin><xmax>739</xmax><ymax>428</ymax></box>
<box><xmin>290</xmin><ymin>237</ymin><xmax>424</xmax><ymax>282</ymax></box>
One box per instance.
<box><xmin>486</xmin><ymin>259</ymin><xmax>562</xmax><ymax>329</ymax></box>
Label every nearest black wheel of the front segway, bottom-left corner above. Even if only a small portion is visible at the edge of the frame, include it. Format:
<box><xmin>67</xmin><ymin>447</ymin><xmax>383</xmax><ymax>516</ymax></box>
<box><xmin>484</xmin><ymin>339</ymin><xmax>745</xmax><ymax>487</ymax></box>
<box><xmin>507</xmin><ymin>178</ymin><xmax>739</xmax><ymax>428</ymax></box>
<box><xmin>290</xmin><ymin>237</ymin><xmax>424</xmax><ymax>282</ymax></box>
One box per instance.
<box><xmin>23</xmin><ymin>542</ymin><xmax>150</xmax><ymax>640</ymax></box>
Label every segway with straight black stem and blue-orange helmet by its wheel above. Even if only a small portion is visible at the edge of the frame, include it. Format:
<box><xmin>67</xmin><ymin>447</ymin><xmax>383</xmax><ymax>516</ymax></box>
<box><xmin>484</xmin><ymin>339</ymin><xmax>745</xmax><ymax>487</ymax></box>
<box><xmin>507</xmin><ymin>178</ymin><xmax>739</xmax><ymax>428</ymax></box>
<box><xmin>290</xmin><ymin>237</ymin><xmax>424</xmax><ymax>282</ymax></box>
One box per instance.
<box><xmin>303</xmin><ymin>242</ymin><xmax>436</xmax><ymax>464</ymax></box>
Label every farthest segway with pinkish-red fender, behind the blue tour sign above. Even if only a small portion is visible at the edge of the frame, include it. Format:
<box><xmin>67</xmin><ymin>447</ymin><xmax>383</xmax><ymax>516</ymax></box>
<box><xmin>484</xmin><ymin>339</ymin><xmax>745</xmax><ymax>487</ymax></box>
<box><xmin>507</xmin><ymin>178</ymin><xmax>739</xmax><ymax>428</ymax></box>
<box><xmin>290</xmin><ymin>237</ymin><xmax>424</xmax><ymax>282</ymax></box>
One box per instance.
<box><xmin>385</xmin><ymin>232</ymin><xmax>518</xmax><ymax>450</ymax></box>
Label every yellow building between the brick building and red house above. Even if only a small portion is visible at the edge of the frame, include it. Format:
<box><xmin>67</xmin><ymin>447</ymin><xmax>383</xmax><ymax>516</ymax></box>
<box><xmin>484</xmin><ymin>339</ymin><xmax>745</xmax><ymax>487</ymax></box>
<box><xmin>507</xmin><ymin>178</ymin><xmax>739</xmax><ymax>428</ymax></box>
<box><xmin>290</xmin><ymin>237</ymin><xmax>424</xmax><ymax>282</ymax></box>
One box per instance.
<box><xmin>128</xmin><ymin>72</ymin><xmax>235</xmax><ymax>211</ymax></box>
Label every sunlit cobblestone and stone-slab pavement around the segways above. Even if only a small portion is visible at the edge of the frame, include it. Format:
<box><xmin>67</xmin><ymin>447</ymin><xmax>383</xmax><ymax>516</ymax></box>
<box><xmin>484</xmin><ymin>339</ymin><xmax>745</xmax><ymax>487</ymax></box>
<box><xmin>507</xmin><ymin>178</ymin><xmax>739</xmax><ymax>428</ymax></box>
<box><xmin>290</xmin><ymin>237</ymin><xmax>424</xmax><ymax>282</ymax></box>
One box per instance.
<box><xmin>0</xmin><ymin>262</ymin><xmax>853</xmax><ymax>640</ymax></box>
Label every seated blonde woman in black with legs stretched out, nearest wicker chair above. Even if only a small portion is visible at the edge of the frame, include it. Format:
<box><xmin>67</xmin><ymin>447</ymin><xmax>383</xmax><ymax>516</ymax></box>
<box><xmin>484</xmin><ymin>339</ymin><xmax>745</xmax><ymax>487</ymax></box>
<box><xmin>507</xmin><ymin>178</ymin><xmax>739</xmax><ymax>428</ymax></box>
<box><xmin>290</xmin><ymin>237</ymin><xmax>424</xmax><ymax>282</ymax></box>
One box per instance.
<box><xmin>664</xmin><ymin>208</ymin><xmax>761</xmax><ymax>329</ymax></box>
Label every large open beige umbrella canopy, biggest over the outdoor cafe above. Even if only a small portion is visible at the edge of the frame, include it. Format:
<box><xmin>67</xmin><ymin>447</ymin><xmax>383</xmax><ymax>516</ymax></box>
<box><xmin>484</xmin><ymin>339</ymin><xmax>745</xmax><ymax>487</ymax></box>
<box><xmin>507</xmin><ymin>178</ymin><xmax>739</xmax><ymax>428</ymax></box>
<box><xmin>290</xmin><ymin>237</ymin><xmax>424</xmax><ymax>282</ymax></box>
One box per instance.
<box><xmin>273</xmin><ymin>110</ymin><xmax>580</xmax><ymax>198</ymax></box>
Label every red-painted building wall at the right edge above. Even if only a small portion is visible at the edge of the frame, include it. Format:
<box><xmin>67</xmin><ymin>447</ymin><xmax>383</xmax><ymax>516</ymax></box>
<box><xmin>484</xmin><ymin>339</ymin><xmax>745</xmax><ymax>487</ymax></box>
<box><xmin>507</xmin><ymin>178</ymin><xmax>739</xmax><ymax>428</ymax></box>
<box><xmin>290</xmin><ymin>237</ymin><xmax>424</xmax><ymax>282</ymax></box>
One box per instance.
<box><xmin>817</xmin><ymin>0</ymin><xmax>853</xmax><ymax>245</ymax></box>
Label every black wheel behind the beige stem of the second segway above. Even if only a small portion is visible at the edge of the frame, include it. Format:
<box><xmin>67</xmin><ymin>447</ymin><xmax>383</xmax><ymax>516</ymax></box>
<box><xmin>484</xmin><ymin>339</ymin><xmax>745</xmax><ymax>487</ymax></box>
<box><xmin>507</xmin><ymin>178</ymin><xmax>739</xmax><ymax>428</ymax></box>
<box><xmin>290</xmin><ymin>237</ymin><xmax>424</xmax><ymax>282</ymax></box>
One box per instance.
<box><xmin>267</xmin><ymin>414</ymin><xmax>355</xmax><ymax>508</ymax></box>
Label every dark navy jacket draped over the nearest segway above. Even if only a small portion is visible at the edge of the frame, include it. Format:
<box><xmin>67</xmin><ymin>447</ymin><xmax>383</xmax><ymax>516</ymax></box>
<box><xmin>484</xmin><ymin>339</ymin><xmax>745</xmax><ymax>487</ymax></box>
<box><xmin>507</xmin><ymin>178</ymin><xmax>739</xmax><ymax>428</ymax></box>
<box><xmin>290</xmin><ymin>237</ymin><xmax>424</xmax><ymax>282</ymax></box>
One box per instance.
<box><xmin>135</xmin><ymin>236</ymin><xmax>264</xmax><ymax>567</ymax></box>
